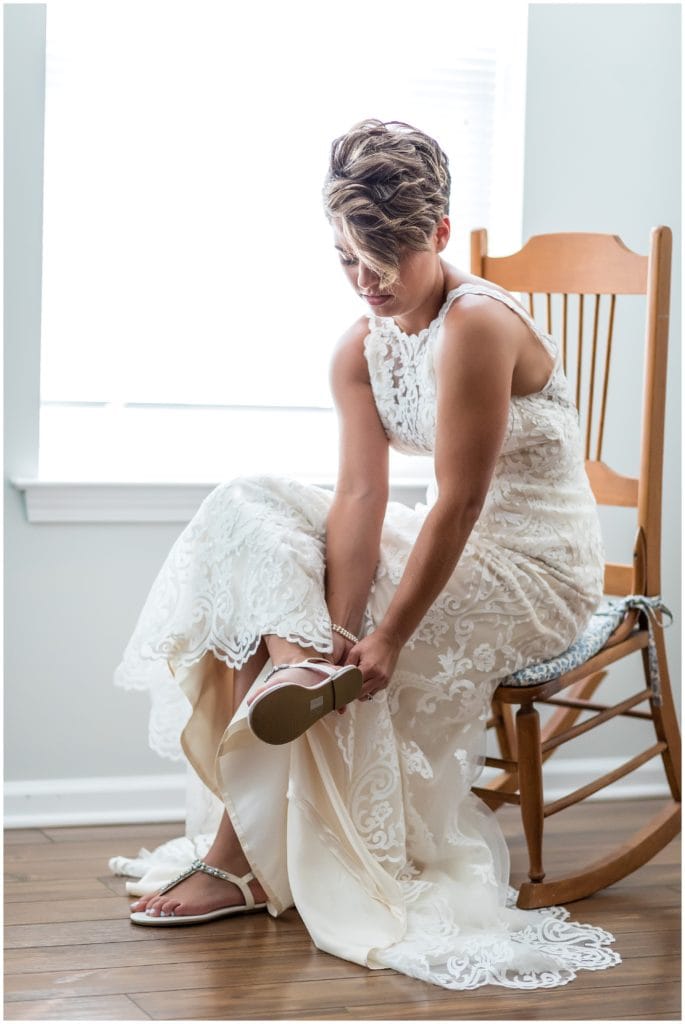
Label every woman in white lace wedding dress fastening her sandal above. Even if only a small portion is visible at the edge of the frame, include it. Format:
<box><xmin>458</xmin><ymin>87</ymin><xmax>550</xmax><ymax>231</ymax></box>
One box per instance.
<box><xmin>113</xmin><ymin>121</ymin><xmax>618</xmax><ymax>988</ymax></box>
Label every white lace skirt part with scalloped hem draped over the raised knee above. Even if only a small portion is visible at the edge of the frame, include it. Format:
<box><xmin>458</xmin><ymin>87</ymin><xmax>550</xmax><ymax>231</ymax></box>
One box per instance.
<box><xmin>114</xmin><ymin>476</ymin><xmax>333</xmax><ymax>761</ymax></box>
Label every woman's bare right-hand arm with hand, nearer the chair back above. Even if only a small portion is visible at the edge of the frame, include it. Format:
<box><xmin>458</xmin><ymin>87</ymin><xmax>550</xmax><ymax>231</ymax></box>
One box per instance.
<box><xmin>348</xmin><ymin>296</ymin><xmax>516</xmax><ymax>693</ymax></box>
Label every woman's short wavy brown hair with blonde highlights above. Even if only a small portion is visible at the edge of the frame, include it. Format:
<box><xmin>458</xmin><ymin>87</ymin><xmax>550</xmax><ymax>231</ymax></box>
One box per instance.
<box><xmin>324</xmin><ymin>119</ymin><xmax>451</xmax><ymax>287</ymax></box>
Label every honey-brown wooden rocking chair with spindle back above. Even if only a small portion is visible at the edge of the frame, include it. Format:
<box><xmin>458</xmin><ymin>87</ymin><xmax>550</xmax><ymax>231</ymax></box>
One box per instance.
<box><xmin>471</xmin><ymin>227</ymin><xmax>680</xmax><ymax>908</ymax></box>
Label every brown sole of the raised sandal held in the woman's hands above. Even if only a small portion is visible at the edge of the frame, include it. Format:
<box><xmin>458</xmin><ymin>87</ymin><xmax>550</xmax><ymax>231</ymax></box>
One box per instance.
<box><xmin>248</xmin><ymin>665</ymin><xmax>363</xmax><ymax>745</ymax></box>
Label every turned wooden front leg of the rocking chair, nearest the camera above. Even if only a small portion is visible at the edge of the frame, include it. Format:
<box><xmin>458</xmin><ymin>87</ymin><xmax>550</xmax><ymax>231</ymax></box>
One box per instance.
<box><xmin>516</xmin><ymin>703</ymin><xmax>545</xmax><ymax>882</ymax></box>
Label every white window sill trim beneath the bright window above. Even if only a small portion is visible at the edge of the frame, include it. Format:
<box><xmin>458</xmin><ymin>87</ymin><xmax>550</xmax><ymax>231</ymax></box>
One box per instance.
<box><xmin>12</xmin><ymin>476</ymin><xmax>428</xmax><ymax>523</ymax></box>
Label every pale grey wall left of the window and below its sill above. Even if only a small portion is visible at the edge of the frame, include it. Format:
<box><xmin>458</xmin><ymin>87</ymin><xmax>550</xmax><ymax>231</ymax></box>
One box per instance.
<box><xmin>4</xmin><ymin>4</ymin><xmax>179</xmax><ymax>794</ymax></box>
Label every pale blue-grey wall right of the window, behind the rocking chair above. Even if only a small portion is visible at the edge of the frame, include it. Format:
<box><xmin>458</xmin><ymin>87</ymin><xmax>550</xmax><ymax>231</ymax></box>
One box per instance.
<box><xmin>523</xmin><ymin>3</ymin><xmax>681</xmax><ymax>770</ymax></box>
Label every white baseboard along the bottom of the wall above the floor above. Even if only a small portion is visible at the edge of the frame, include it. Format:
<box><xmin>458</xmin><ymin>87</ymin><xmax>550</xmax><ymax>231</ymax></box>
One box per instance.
<box><xmin>4</xmin><ymin>758</ymin><xmax>669</xmax><ymax>828</ymax></box>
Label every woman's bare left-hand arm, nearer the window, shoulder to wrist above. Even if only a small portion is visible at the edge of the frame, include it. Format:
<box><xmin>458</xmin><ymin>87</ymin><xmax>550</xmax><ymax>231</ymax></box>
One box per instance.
<box><xmin>326</xmin><ymin>317</ymin><xmax>388</xmax><ymax>634</ymax></box>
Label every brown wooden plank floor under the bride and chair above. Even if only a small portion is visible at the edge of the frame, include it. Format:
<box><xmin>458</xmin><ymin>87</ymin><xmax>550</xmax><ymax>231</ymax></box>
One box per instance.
<box><xmin>5</xmin><ymin>801</ymin><xmax>681</xmax><ymax>1021</ymax></box>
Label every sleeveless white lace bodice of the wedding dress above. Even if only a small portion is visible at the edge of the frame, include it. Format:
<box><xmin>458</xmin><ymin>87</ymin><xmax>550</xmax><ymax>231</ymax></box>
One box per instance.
<box><xmin>365</xmin><ymin>284</ymin><xmax>604</xmax><ymax>594</ymax></box>
